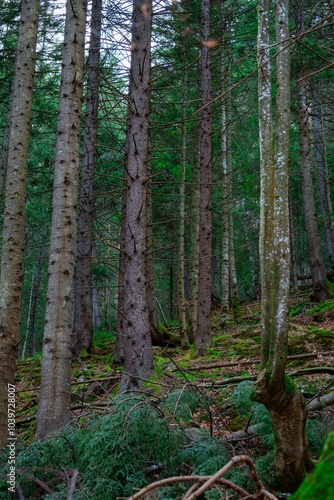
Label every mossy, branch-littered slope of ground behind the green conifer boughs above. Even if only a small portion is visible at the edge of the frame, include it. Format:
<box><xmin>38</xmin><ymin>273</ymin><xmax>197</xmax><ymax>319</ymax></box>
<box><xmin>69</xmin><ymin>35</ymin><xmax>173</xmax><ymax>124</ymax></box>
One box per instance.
<box><xmin>11</xmin><ymin>295</ymin><xmax>334</xmax><ymax>498</ymax></box>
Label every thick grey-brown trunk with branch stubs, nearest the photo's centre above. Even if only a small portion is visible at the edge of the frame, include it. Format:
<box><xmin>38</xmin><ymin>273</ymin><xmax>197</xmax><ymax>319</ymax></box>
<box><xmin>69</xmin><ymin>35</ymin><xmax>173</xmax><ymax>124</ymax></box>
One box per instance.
<box><xmin>121</xmin><ymin>0</ymin><xmax>153</xmax><ymax>391</ymax></box>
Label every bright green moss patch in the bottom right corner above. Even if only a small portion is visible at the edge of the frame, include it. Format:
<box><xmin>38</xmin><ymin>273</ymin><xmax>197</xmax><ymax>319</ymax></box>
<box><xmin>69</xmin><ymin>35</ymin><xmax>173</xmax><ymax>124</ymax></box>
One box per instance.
<box><xmin>291</xmin><ymin>432</ymin><xmax>334</xmax><ymax>500</ymax></box>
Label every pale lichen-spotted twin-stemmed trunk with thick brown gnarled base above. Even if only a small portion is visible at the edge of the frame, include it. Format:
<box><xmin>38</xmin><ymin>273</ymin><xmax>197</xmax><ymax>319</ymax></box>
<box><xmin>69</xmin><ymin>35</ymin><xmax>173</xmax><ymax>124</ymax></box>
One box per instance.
<box><xmin>254</xmin><ymin>0</ymin><xmax>307</xmax><ymax>491</ymax></box>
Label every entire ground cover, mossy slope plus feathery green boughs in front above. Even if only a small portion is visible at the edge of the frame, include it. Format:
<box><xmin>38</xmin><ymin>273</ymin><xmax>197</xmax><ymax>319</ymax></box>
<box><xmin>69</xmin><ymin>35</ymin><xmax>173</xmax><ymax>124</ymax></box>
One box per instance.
<box><xmin>0</xmin><ymin>296</ymin><xmax>334</xmax><ymax>500</ymax></box>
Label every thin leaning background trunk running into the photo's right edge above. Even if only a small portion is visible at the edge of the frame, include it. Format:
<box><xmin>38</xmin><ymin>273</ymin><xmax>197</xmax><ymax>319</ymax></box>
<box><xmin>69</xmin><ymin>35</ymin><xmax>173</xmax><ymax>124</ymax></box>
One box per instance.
<box><xmin>311</xmin><ymin>83</ymin><xmax>334</xmax><ymax>269</ymax></box>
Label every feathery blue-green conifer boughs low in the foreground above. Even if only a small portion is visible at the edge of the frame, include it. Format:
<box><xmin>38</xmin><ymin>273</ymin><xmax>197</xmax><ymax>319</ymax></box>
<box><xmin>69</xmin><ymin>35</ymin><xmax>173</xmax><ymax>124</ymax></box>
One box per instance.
<box><xmin>0</xmin><ymin>390</ymin><xmax>232</xmax><ymax>500</ymax></box>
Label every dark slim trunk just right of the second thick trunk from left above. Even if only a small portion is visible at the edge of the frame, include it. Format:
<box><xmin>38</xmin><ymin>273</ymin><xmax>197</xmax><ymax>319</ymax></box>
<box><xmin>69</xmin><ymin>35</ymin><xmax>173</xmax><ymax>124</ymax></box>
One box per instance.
<box><xmin>72</xmin><ymin>0</ymin><xmax>102</xmax><ymax>356</ymax></box>
